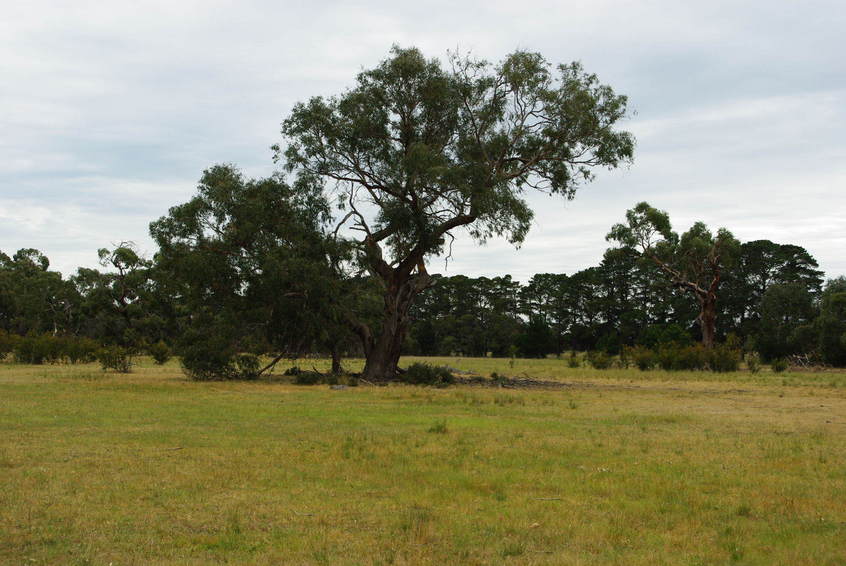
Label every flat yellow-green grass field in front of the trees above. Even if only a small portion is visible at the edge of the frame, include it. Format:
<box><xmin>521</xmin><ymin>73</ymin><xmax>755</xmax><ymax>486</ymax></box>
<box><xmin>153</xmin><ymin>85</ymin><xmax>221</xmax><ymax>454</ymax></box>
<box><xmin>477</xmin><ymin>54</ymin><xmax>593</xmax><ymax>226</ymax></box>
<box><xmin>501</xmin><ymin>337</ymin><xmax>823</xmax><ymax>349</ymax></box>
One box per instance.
<box><xmin>0</xmin><ymin>358</ymin><xmax>846</xmax><ymax>566</ymax></box>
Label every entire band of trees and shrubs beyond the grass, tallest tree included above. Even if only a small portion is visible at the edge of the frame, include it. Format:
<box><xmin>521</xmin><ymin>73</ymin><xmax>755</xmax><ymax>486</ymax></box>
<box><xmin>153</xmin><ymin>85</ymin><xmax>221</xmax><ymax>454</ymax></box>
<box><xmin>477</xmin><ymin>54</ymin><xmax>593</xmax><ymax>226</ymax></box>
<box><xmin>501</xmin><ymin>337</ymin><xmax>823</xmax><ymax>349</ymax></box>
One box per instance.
<box><xmin>0</xmin><ymin>47</ymin><xmax>846</xmax><ymax>380</ymax></box>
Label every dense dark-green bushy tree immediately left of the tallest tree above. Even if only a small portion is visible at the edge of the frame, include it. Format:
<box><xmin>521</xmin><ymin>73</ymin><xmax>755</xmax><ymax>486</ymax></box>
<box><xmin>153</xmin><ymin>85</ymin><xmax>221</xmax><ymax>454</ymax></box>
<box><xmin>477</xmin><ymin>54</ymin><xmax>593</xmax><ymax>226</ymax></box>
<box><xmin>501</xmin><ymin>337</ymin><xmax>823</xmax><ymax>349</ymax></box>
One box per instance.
<box><xmin>150</xmin><ymin>165</ymin><xmax>354</xmax><ymax>380</ymax></box>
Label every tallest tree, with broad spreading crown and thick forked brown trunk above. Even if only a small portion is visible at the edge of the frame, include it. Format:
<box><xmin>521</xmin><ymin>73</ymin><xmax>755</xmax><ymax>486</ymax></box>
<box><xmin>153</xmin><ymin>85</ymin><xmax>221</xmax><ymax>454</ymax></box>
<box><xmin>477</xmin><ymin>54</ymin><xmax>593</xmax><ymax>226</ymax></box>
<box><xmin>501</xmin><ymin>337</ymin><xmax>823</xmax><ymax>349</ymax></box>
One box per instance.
<box><xmin>276</xmin><ymin>47</ymin><xmax>634</xmax><ymax>378</ymax></box>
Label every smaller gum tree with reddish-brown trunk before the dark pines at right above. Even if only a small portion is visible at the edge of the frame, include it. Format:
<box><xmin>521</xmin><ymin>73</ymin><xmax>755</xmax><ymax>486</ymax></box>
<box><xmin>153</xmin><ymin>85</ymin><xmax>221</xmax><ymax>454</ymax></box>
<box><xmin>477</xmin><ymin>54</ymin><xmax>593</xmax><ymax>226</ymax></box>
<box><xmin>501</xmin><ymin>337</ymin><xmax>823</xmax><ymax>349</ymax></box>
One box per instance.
<box><xmin>607</xmin><ymin>202</ymin><xmax>740</xmax><ymax>348</ymax></box>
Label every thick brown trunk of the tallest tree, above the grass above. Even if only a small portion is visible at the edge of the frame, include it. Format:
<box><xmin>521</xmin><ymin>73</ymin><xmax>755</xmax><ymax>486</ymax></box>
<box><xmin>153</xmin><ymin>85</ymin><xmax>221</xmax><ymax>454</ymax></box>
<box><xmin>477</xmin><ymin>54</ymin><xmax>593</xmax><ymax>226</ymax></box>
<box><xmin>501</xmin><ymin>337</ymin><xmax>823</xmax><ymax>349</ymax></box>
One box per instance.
<box><xmin>362</xmin><ymin>272</ymin><xmax>432</xmax><ymax>380</ymax></box>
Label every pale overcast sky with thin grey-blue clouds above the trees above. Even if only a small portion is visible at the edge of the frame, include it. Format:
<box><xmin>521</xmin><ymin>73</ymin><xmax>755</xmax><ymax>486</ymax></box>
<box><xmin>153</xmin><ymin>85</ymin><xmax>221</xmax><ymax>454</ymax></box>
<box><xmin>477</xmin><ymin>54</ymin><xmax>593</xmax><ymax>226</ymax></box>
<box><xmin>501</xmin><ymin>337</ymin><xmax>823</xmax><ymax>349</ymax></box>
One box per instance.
<box><xmin>0</xmin><ymin>0</ymin><xmax>846</xmax><ymax>281</ymax></box>
